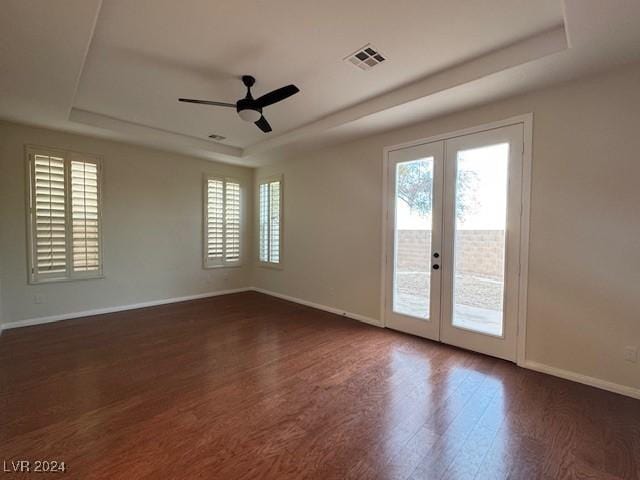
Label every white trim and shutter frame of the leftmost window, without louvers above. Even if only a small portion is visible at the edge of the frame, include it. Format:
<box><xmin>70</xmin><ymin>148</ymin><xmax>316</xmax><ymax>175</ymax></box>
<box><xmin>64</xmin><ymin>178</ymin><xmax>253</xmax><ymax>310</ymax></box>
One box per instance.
<box><xmin>24</xmin><ymin>144</ymin><xmax>105</xmax><ymax>285</ymax></box>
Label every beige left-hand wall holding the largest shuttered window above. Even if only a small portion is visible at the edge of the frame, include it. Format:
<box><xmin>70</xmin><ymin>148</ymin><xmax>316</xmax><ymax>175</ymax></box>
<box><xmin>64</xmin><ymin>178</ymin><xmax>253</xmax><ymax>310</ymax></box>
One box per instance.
<box><xmin>0</xmin><ymin>122</ymin><xmax>253</xmax><ymax>324</ymax></box>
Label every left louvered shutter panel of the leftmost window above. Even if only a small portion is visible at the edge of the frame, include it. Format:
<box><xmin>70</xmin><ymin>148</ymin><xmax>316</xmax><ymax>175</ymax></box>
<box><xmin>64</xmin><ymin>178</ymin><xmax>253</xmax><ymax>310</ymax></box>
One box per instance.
<box><xmin>31</xmin><ymin>155</ymin><xmax>67</xmax><ymax>277</ymax></box>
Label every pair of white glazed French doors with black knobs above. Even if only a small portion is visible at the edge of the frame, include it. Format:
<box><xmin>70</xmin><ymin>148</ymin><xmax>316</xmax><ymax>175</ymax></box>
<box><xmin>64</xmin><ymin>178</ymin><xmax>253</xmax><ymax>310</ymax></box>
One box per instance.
<box><xmin>385</xmin><ymin>124</ymin><xmax>523</xmax><ymax>360</ymax></box>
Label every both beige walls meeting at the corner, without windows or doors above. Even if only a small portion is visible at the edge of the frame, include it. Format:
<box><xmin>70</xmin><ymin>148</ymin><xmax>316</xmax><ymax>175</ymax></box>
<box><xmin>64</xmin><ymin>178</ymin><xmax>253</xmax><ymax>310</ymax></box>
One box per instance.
<box><xmin>0</xmin><ymin>65</ymin><xmax>640</xmax><ymax>396</ymax></box>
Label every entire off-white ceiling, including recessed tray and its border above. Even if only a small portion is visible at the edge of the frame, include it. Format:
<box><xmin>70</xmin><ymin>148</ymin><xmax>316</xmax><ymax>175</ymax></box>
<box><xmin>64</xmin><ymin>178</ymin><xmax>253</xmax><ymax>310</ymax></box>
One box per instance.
<box><xmin>0</xmin><ymin>0</ymin><xmax>640</xmax><ymax>165</ymax></box>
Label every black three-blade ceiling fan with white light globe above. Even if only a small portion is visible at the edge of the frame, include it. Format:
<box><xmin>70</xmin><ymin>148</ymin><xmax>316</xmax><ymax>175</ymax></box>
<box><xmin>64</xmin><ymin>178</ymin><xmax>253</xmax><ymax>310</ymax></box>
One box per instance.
<box><xmin>178</xmin><ymin>75</ymin><xmax>300</xmax><ymax>133</ymax></box>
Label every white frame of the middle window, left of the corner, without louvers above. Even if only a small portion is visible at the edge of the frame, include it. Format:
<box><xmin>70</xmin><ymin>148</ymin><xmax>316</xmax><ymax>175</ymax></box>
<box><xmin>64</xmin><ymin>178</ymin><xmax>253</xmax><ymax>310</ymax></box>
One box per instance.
<box><xmin>202</xmin><ymin>173</ymin><xmax>245</xmax><ymax>270</ymax></box>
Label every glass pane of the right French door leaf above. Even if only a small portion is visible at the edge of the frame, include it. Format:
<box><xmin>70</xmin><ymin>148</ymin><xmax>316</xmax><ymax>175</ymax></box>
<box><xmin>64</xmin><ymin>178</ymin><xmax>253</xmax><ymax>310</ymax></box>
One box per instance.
<box><xmin>453</xmin><ymin>143</ymin><xmax>509</xmax><ymax>336</ymax></box>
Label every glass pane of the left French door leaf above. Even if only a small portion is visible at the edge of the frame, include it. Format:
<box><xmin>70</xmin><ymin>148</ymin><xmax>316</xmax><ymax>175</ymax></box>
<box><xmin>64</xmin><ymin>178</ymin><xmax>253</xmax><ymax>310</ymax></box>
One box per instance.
<box><xmin>393</xmin><ymin>157</ymin><xmax>434</xmax><ymax>320</ymax></box>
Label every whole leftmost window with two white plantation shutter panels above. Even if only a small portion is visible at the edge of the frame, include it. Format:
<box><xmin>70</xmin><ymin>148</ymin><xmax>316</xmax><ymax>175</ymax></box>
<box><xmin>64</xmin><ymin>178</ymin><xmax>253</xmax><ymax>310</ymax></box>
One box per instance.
<box><xmin>27</xmin><ymin>147</ymin><xmax>102</xmax><ymax>283</ymax></box>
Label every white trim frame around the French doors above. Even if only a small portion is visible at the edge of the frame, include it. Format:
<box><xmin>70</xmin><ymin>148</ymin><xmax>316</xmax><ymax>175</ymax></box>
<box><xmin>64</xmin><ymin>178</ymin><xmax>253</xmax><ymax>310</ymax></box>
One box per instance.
<box><xmin>380</xmin><ymin>113</ymin><xmax>533</xmax><ymax>366</ymax></box>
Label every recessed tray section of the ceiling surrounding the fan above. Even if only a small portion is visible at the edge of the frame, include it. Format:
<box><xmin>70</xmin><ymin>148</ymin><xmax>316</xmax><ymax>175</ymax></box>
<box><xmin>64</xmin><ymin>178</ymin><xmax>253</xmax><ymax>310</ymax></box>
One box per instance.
<box><xmin>76</xmin><ymin>0</ymin><xmax>562</xmax><ymax>148</ymax></box>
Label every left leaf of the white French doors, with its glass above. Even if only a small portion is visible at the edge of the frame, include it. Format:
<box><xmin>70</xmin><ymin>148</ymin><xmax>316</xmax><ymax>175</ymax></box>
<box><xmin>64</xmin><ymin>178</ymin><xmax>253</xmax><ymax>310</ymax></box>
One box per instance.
<box><xmin>385</xmin><ymin>142</ymin><xmax>444</xmax><ymax>340</ymax></box>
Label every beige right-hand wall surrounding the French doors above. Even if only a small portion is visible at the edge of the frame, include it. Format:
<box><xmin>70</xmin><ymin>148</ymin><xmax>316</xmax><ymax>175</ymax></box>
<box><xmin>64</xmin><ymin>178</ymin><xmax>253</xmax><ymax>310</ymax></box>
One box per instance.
<box><xmin>253</xmin><ymin>64</ymin><xmax>640</xmax><ymax>388</ymax></box>
